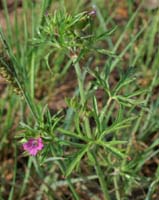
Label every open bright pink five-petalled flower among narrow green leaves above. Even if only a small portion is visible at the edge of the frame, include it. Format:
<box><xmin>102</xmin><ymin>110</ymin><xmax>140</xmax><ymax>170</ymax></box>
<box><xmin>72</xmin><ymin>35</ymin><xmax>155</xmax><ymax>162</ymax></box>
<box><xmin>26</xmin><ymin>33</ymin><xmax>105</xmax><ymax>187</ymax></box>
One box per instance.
<box><xmin>23</xmin><ymin>137</ymin><xmax>44</xmax><ymax>156</ymax></box>
